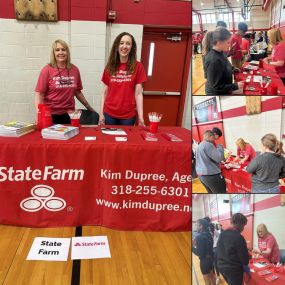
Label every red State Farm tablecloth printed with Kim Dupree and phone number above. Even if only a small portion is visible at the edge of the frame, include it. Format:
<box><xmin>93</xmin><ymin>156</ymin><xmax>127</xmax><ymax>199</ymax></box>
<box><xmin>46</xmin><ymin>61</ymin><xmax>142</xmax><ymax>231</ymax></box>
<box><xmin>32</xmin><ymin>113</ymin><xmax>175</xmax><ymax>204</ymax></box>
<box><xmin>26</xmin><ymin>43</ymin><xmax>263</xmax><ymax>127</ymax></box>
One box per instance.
<box><xmin>0</xmin><ymin>126</ymin><xmax>191</xmax><ymax>231</ymax></box>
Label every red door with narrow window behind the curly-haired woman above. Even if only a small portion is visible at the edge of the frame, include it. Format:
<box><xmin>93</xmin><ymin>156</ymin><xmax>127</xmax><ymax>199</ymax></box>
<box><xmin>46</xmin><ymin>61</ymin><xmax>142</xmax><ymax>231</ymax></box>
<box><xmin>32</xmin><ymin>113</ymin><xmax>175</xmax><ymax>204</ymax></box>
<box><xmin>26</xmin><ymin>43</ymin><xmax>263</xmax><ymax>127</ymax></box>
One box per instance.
<box><xmin>141</xmin><ymin>29</ymin><xmax>190</xmax><ymax>126</ymax></box>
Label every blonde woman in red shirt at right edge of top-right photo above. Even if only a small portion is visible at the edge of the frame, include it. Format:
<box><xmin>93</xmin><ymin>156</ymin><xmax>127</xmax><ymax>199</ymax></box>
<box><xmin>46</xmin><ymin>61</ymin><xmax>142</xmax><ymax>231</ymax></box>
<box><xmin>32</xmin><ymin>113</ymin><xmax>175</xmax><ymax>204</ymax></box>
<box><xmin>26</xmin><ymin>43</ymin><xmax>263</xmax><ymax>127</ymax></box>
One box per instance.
<box><xmin>264</xmin><ymin>29</ymin><xmax>285</xmax><ymax>85</ymax></box>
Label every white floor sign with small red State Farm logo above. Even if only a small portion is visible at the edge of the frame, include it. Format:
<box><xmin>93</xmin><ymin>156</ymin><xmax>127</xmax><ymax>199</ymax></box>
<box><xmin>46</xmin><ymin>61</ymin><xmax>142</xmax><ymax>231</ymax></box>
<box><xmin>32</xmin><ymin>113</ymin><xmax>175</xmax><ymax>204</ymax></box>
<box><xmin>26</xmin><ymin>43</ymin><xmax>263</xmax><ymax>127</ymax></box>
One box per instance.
<box><xmin>71</xmin><ymin>236</ymin><xmax>111</xmax><ymax>259</ymax></box>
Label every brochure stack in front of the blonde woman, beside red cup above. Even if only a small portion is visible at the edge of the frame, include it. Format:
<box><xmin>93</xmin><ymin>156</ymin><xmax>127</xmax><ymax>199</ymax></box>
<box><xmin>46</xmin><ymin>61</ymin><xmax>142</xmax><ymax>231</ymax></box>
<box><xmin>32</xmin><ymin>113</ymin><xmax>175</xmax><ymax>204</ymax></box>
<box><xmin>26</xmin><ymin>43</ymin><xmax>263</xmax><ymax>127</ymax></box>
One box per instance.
<box><xmin>42</xmin><ymin>124</ymin><xmax>79</xmax><ymax>140</ymax></box>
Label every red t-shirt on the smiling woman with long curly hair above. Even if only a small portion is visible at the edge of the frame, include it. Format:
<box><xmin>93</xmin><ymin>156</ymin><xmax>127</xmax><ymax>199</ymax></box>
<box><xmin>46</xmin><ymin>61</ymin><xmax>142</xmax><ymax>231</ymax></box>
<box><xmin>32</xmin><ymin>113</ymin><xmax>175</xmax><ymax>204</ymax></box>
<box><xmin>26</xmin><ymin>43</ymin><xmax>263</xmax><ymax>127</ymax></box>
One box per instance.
<box><xmin>102</xmin><ymin>61</ymin><xmax>146</xmax><ymax>119</ymax></box>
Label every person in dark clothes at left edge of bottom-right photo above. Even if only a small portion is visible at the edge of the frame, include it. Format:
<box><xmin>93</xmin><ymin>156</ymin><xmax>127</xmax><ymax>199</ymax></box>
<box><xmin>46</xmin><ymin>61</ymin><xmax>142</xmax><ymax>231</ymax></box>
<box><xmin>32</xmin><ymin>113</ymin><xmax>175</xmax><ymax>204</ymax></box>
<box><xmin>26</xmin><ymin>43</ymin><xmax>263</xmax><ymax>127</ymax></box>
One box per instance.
<box><xmin>192</xmin><ymin>219</ymin><xmax>215</xmax><ymax>285</ymax></box>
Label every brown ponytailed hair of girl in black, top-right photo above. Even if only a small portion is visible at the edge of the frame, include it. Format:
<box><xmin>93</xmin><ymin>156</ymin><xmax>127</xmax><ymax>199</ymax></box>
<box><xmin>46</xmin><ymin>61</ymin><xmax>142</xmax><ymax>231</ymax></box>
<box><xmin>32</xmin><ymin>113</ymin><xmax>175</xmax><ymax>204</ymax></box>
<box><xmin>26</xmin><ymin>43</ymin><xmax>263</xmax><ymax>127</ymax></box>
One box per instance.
<box><xmin>202</xmin><ymin>27</ymin><xmax>231</xmax><ymax>55</ymax></box>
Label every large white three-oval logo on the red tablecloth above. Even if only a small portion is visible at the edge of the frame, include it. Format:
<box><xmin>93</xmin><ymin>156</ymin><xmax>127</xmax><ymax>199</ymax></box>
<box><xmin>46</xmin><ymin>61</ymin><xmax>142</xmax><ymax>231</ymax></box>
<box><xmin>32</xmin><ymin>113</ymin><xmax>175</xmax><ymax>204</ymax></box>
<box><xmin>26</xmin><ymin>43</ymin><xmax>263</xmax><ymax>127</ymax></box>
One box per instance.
<box><xmin>20</xmin><ymin>185</ymin><xmax>66</xmax><ymax>212</ymax></box>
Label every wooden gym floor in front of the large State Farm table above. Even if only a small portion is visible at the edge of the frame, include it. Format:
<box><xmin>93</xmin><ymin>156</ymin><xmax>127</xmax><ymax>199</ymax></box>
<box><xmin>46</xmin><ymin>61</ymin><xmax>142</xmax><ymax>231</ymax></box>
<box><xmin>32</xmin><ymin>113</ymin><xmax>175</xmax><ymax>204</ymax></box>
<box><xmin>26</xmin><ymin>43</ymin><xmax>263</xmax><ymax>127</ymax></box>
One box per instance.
<box><xmin>0</xmin><ymin>225</ymin><xmax>191</xmax><ymax>285</ymax></box>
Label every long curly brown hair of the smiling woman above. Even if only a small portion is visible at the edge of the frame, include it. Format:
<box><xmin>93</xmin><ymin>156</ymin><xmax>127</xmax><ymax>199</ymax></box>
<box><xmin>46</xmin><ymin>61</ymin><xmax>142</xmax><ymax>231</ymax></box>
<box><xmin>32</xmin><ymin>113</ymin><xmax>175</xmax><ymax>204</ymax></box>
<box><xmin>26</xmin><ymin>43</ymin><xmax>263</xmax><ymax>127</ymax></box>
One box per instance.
<box><xmin>106</xmin><ymin>32</ymin><xmax>137</xmax><ymax>75</ymax></box>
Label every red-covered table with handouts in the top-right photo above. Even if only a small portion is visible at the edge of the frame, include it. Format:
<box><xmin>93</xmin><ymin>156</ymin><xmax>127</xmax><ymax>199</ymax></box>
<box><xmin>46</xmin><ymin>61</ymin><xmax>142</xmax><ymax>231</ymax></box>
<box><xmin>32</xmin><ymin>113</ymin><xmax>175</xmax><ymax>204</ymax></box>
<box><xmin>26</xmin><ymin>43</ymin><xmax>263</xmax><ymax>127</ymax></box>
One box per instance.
<box><xmin>236</xmin><ymin>62</ymin><xmax>285</xmax><ymax>95</ymax></box>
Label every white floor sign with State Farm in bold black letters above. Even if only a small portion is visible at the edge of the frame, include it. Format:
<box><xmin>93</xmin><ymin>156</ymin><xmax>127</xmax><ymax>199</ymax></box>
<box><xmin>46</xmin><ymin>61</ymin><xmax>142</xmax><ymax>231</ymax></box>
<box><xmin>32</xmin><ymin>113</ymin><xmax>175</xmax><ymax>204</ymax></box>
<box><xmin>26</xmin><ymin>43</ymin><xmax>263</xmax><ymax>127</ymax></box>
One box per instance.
<box><xmin>27</xmin><ymin>237</ymin><xmax>70</xmax><ymax>261</ymax></box>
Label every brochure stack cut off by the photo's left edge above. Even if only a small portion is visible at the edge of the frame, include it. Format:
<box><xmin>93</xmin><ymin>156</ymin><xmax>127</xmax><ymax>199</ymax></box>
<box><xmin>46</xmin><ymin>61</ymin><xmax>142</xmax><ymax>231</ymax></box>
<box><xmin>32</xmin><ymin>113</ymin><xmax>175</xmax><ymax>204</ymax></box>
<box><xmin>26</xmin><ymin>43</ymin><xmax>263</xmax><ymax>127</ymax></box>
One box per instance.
<box><xmin>0</xmin><ymin>121</ymin><xmax>36</xmax><ymax>137</ymax></box>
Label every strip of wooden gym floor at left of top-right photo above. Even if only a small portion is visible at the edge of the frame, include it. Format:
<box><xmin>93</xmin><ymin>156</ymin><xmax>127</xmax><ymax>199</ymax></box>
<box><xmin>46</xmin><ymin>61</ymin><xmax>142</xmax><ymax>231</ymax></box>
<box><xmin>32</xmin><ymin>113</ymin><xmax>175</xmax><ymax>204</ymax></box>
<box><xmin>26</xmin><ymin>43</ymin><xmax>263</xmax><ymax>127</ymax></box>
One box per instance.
<box><xmin>192</xmin><ymin>54</ymin><xmax>206</xmax><ymax>95</ymax></box>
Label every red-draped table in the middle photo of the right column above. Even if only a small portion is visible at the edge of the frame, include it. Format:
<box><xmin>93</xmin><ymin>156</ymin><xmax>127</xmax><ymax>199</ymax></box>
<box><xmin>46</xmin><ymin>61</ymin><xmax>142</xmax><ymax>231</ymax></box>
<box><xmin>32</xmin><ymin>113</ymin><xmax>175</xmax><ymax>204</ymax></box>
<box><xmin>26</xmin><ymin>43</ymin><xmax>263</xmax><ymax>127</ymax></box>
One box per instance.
<box><xmin>221</xmin><ymin>165</ymin><xmax>285</xmax><ymax>193</ymax></box>
